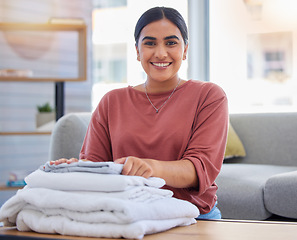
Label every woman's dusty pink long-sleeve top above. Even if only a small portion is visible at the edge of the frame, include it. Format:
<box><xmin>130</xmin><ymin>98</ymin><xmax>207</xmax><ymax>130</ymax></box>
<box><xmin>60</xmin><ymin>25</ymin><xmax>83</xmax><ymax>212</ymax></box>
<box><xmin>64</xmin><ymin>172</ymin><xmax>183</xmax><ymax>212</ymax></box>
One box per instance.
<box><xmin>80</xmin><ymin>80</ymin><xmax>229</xmax><ymax>214</ymax></box>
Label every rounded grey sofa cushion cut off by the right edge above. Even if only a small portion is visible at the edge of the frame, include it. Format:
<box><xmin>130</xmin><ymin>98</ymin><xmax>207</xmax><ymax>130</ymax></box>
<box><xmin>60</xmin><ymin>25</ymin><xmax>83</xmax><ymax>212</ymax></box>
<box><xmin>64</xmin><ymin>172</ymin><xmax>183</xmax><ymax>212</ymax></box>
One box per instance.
<box><xmin>264</xmin><ymin>170</ymin><xmax>297</xmax><ymax>218</ymax></box>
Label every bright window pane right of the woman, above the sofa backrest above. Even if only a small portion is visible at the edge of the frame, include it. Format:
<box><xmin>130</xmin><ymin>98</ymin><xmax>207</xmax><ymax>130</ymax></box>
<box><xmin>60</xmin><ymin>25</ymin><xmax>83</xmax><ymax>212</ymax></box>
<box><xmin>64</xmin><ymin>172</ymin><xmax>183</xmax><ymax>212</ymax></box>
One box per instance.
<box><xmin>209</xmin><ymin>0</ymin><xmax>297</xmax><ymax>113</ymax></box>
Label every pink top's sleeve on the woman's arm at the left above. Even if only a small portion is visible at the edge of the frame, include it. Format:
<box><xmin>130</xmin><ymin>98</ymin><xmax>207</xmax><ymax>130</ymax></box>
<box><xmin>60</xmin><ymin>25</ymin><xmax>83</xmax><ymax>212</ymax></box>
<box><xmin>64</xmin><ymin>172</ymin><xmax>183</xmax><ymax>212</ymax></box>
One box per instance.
<box><xmin>79</xmin><ymin>95</ymin><xmax>112</xmax><ymax>162</ymax></box>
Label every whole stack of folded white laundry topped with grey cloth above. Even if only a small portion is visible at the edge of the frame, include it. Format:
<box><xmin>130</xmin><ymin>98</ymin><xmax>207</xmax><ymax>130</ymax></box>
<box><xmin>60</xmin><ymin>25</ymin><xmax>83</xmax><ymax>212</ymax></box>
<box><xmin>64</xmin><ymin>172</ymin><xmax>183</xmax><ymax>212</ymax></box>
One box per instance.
<box><xmin>0</xmin><ymin>160</ymin><xmax>199</xmax><ymax>239</ymax></box>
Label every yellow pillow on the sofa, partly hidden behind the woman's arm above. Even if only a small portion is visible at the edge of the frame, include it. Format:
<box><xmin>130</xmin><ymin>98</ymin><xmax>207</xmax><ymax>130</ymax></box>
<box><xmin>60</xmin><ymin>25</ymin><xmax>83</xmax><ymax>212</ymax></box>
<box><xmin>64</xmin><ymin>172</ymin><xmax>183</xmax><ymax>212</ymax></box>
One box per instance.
<box><xmin>225</xmin><ymin>122</ymin><xmax>246</xmax><ymax>159</ymax></box>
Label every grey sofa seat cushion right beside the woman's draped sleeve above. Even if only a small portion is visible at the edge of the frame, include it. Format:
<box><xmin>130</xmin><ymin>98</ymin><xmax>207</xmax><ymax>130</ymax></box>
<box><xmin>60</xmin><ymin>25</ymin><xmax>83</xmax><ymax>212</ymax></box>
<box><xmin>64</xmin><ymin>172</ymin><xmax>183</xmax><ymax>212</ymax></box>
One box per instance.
<box><xmin>216</xmin><ymin>163</ymin><xmax>292</xmax><ymax>220</ymax></box>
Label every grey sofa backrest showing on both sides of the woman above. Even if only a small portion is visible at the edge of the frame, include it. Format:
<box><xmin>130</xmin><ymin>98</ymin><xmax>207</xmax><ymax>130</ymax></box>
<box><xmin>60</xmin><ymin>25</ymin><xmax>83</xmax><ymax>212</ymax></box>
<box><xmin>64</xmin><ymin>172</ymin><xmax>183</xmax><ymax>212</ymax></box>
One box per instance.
<box><xmin>49</xmin><ymin>112</ymin><xmax>297</xmax><ymax>166</ymax></box>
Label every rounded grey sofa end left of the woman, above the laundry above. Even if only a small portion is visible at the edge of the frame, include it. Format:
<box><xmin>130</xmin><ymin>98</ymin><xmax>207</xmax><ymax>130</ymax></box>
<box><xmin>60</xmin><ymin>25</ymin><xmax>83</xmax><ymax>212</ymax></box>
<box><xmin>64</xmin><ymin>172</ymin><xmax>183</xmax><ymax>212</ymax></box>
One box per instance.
<box><xmin>49</xmin><ymin>112</ymin><xmax>91</xmax><ymax>160</ymax></box>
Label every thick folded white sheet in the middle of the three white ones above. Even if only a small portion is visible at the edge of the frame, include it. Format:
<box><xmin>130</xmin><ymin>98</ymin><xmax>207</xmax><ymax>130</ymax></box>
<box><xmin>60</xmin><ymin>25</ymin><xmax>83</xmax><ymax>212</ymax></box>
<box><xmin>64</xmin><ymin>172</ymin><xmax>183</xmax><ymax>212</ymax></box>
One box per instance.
<box><xmin>0</xmin><ymin>187</ymin><xmax>199</xmax><ymax>226</ymax></box>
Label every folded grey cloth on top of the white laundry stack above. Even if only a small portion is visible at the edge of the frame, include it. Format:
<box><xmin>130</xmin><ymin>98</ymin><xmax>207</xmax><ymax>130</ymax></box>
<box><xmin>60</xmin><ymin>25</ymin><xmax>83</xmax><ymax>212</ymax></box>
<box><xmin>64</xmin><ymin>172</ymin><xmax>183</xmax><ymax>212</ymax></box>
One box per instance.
<box><xmin>40</xmin><ymin>160</ymin><xmax>123</xmax><ymax>174</ymax></box>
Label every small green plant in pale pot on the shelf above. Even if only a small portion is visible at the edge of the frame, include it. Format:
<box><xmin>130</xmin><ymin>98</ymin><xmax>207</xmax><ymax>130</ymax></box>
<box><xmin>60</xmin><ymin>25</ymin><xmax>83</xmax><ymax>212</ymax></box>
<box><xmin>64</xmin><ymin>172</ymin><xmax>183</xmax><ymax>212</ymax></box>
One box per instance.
<box><xmin>36</xmin><ymin>102</ymin><xmax>56</xmax><ymax>128</ymax></box>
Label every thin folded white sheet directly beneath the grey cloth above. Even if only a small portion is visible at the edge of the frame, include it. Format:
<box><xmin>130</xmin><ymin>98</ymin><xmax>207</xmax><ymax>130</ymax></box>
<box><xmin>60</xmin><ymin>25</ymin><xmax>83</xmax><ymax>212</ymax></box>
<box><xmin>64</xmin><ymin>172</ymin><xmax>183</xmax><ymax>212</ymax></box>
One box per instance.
<box><xmin>25</xmin><ymin>169</ymin><xmax>165</xmax><ymax>192</ymax></box>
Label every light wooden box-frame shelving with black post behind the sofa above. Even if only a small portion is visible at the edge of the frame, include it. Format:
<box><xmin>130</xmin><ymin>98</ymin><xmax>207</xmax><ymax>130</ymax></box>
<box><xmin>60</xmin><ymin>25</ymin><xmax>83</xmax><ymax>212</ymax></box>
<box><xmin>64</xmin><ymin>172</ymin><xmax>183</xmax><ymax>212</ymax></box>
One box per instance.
<box><xmin>0</xmin><ymin>20</ymin><xmax>87</xmax><ymax>129</ymax></box>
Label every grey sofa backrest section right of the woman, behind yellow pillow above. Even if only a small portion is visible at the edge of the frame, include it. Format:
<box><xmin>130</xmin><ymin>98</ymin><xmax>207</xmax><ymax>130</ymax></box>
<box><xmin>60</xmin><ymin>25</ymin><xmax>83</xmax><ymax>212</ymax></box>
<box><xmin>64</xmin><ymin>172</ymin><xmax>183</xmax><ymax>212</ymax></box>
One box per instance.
<box><xmin>226</xmin><ymin>112</ymin><xmax>297</xmax><ymax>166</ymax></box>
